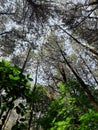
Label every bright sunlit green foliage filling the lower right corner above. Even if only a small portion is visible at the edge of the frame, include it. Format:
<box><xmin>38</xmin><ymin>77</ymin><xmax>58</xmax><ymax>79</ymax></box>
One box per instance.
<box><xmin>39</xmin><ymin>80</ymin><xmax>98</xmax><ymax>130</ymax></box>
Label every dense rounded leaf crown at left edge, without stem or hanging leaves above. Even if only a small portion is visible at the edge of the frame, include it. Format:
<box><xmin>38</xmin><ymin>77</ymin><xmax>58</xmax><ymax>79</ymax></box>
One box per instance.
<box><xmin>0</xmin><ymin>61</ymin><xmax>30</xmax><ymax>100</ymax></box>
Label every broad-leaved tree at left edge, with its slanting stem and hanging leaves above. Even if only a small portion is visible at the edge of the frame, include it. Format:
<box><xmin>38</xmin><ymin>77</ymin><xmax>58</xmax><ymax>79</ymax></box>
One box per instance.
<box><xmin>0</xmin><ymin>60</ymin><xmax>32</xmax><ymax>129</ymax></box>
